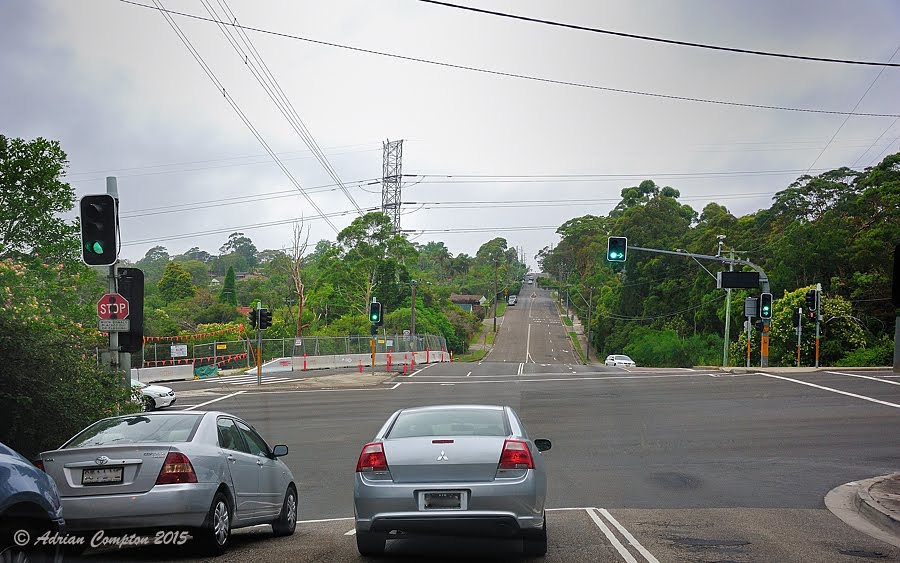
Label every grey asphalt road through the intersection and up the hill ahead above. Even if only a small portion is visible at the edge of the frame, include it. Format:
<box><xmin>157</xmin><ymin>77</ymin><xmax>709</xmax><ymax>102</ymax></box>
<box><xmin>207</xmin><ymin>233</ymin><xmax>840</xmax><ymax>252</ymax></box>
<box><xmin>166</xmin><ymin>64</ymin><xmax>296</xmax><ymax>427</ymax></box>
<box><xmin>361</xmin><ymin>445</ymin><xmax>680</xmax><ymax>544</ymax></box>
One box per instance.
<box><xmin>81</xmin><ymin>286</ymin><xmax>900</xmax><ymax>563</ymax></box>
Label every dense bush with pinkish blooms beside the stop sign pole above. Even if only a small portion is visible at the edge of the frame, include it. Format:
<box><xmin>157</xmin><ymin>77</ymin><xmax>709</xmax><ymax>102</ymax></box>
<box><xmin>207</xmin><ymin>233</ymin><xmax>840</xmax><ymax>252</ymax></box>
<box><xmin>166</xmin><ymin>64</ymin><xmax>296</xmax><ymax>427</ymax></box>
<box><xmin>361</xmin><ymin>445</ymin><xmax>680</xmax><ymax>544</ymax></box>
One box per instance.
<box><xmin>0</xmin><ymin>259</ymin><xmax>139</xmax><ymax>456</ymax></box>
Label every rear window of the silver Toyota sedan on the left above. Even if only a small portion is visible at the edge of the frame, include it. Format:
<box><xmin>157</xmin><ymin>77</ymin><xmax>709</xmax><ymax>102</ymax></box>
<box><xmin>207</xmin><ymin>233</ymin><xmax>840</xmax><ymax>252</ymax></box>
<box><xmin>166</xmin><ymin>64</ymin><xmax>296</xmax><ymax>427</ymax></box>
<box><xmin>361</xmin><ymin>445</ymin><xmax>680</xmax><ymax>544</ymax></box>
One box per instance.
<box><xmin>63</xmin><ymin>413</ymin><xmax>202</xmax><ymax>449</ymax></box>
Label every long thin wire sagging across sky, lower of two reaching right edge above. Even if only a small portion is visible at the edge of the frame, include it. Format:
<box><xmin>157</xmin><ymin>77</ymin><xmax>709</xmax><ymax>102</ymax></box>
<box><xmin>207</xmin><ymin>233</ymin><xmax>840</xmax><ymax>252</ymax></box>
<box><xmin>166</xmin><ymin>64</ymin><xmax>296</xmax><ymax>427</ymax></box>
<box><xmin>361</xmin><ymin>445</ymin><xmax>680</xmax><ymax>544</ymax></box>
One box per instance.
<box><xmin>119</xmin><ymin>0</ymin><xmax>900</xmax><ymax>117</ymax></box>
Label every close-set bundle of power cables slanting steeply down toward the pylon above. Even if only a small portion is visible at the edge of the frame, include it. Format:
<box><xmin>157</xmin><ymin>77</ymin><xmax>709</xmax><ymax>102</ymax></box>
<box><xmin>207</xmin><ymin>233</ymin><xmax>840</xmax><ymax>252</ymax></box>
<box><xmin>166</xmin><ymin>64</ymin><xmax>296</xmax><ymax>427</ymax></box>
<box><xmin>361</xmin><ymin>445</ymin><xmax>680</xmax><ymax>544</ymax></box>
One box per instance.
<box><xmin>201</xmin><ymin>0</ymin><xmax>362</xmax><ymax>215</ymax></box>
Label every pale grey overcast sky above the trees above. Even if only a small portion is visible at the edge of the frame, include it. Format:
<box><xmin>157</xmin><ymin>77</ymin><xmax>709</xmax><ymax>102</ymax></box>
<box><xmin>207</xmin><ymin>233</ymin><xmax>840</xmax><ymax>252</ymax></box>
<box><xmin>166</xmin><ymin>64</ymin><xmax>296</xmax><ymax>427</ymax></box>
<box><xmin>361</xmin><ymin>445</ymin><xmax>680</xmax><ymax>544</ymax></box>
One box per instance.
<box><xmin>0</xmin><ymin>0</ymin><xmax>900</xmax><ymax>265</ymax></box>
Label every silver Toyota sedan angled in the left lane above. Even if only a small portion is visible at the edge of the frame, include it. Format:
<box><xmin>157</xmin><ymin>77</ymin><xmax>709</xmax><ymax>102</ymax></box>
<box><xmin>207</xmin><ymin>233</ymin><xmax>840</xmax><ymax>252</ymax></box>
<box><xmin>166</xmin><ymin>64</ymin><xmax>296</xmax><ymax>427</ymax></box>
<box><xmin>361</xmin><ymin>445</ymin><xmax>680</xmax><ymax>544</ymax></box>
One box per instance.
<box><xmin>41</xmin><ymin>411</ymin><xmax>297</xmax><ymax>554</ymax></box>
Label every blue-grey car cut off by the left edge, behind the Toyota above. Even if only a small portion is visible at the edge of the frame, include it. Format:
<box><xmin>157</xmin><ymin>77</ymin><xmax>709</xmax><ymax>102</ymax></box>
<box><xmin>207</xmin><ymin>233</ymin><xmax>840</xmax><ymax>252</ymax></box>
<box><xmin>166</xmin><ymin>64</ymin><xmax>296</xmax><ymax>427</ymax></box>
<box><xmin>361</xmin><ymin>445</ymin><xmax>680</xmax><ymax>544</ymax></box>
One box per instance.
<box><xmin>0</xmin><ymin>443</ymin><xmax>66</xmax><ymax>561</ymax></box>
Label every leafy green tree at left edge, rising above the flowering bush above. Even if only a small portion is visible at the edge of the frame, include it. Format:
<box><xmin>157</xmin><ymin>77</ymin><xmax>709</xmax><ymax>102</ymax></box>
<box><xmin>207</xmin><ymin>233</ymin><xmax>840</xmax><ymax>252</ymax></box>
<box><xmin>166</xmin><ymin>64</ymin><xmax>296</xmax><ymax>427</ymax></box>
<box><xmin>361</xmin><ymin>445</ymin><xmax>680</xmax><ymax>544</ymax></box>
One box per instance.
<box><xmin>0</xmin><ymin>135</ymin><xmax>79</xmax><ymax>258</ymax></box>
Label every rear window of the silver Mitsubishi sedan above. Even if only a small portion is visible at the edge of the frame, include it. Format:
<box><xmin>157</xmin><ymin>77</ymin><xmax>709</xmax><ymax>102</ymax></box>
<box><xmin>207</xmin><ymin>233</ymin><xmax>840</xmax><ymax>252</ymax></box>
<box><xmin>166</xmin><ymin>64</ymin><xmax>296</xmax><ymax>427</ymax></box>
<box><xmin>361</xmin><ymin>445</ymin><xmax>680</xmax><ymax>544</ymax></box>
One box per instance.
<box><xmin>386</xmin><ymin>409</ymin><xmax>509</xmax><ymax>438</ymax></box>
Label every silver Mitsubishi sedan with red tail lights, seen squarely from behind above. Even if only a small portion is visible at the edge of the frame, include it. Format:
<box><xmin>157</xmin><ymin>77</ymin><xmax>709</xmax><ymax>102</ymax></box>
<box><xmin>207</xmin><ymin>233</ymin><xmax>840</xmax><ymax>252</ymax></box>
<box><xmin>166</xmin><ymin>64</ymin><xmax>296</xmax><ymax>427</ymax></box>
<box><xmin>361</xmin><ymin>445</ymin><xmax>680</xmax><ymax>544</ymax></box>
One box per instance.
<box><xmin>353</xmin><ymin>405</ymin><xmax>550</xmax><ymax>555</ymax></box>
